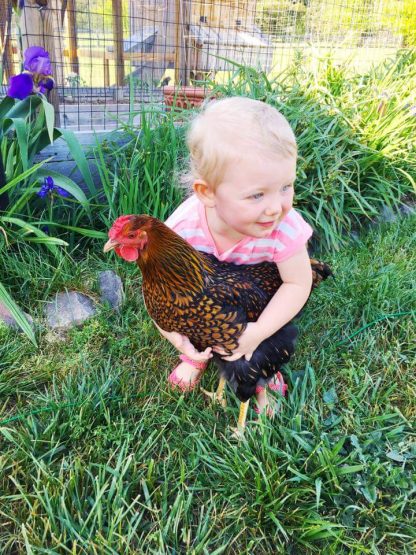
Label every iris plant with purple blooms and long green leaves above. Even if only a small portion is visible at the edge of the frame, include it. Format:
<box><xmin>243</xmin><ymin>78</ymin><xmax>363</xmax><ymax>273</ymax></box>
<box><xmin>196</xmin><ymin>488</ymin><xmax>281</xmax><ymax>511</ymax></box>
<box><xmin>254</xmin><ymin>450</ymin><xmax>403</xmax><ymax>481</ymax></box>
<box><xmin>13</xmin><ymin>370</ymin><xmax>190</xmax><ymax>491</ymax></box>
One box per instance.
<box><xmin>0</xmin><ymin>51</ymin><xmax>95</xmax><ymax>343</ymax></box>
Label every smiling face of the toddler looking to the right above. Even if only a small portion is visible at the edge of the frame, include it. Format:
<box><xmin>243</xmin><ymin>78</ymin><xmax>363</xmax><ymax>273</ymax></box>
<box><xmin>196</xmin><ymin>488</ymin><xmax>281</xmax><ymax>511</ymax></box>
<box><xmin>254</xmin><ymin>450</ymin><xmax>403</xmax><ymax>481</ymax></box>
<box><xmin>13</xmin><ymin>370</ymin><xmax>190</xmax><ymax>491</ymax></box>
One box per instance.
<box><xmin>213</xmin><ymin>153</ymin><xmax>296</xmax><ymax>239</ymax></box>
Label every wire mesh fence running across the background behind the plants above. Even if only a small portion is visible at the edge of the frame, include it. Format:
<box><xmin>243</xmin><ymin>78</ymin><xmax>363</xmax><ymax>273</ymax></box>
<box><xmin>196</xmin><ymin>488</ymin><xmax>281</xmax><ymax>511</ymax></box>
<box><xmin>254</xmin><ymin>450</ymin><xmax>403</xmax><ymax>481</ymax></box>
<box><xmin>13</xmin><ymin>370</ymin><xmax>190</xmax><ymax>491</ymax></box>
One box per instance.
<box><xmin>0</xmin><ymin>0</ymin><xmax>416</xmax><ymax>130</ymax></box>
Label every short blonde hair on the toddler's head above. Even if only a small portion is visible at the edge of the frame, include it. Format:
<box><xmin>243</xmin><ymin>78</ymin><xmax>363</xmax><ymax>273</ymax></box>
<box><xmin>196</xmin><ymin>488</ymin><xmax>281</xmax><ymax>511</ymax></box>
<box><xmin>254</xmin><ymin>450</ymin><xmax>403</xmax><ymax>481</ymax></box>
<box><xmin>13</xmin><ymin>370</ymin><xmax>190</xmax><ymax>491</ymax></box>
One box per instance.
<box><xmin>181</xmin><ymin>97</ymin><xmax>297</xmax><ymax>194</ymax></box>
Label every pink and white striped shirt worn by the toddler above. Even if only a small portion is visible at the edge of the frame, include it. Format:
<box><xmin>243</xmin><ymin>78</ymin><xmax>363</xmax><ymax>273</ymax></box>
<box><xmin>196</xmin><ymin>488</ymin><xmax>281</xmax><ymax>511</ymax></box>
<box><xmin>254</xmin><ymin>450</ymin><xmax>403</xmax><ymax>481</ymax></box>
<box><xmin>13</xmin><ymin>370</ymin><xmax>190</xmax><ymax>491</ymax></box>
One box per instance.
<box><xmin>165</xmin><ymin>195</ymin><xmax>312</xmax><ymax>264</ymax></box>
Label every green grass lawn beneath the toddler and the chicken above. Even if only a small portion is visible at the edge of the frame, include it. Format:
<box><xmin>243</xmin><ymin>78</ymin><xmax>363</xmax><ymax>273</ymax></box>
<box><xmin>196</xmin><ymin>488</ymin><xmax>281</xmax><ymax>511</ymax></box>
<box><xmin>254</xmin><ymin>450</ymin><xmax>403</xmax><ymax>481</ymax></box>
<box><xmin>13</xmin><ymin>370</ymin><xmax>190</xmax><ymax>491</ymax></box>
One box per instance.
<box><xmin>0</xmin><ymin>218</ymin><xmax>416</xmax><ymax>555</ymax></box>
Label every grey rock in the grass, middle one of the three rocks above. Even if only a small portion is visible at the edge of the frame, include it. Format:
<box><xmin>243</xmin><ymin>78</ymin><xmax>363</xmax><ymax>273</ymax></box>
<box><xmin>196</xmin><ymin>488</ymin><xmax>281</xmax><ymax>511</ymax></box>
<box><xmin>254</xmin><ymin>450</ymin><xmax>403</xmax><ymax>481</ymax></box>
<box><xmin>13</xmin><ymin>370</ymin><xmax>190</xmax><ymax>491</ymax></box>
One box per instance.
<box><xmin>45</xmin><ymin>291</ymin><xmax>97</xmax><ymax>330</ymax></box>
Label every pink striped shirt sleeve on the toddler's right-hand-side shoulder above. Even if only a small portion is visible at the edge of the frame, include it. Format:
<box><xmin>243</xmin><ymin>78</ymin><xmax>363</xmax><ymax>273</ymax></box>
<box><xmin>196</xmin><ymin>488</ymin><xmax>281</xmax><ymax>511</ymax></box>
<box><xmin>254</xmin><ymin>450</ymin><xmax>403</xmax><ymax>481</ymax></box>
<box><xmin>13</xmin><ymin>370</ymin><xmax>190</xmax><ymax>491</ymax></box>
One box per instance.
<box><xmin>273</xmin><ymin>208</ymin><xmax>313</xmax><ymax>264</ymax></box>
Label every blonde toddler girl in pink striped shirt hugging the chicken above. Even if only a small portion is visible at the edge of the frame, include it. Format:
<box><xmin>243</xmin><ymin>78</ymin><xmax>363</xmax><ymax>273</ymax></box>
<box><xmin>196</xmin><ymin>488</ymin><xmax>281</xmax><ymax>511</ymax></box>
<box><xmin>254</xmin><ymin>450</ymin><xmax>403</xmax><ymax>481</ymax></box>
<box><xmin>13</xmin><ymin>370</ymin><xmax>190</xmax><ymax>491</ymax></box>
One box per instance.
<box><xmin>159</xmin><ymin>97</ymin><xmax>312</xmax><ymax>413</ymax></box>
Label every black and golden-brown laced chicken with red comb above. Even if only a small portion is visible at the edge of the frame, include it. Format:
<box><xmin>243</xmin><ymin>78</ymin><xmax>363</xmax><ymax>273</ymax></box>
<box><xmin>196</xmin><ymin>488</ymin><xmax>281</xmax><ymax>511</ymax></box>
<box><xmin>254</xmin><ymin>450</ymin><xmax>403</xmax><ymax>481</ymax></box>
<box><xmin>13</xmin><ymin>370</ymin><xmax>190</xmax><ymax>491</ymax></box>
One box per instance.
<box><xmin>104</xmin><ymin>215</ymin><xmax>331</xmax><ymax>429</ymax></box>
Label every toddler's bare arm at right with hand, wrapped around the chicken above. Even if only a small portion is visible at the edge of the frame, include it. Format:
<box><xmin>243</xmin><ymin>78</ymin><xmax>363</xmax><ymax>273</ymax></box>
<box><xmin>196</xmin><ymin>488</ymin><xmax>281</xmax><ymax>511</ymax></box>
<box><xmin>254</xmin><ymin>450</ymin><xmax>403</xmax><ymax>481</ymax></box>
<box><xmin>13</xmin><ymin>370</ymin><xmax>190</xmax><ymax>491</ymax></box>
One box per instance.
<box><xmin>218</xmin><ymin>246</ymin><xmax>312</xmax><ymax>360</ymax></box>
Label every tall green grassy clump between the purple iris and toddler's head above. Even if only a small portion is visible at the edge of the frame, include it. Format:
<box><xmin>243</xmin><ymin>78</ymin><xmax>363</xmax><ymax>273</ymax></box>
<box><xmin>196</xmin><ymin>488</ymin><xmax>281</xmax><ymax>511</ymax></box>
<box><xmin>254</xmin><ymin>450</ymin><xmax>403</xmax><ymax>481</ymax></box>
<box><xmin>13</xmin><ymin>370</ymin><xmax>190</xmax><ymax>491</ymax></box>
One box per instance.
<box><xmin>96</xmin><ymin>110</ymin><xmax>185</xmax><ymax>227</ymax></box>
